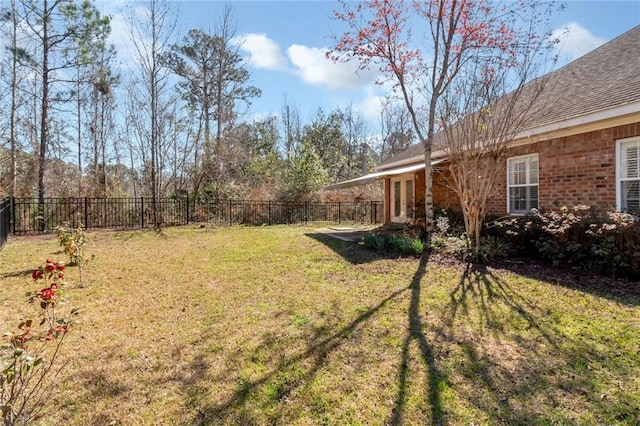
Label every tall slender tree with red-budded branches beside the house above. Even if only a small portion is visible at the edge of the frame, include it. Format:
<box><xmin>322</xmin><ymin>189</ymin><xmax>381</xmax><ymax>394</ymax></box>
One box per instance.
<box><xmin>328</xmin><ymin>0</ymin><xmax>550</xmax><ymax>235</ymax></box>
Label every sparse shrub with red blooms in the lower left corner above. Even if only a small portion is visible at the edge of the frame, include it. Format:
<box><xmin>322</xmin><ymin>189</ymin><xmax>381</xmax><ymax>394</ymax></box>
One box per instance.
<box><xmin>0</xmin><ymin>260</ymin><xmax>78</xmax><ymax>426</ymax></box>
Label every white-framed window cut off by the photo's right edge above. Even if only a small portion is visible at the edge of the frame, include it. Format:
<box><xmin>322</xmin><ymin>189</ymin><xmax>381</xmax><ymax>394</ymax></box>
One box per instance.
<box><xmin>616</xmin><ymin>138</ymin><xmax>640</xmax><ymax>212</ymax></box>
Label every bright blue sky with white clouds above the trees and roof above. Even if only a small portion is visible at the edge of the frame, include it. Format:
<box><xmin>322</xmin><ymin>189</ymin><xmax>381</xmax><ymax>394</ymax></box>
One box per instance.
<box><xmin>105</xmin><ymin>0</ymin><xmax>640</xmax><ymax>126</ymax></box>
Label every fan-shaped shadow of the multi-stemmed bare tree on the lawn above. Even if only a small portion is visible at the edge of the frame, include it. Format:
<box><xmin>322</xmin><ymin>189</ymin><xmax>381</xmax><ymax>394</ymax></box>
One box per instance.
<box><xmin>433</xmin><ymin>265</ymin><xmax>640</xmax><ymax>424</ymax></box>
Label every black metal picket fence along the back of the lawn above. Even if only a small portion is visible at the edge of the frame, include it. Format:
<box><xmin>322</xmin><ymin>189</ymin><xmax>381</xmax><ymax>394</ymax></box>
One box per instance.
<box><xmin>8</xmin><ymin>197</ymin><xmax>383</xmax><ymax>234</ymax></box>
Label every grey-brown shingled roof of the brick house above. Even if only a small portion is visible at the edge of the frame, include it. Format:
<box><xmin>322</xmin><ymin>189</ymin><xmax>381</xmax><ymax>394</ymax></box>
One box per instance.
<box><xmin>376</xmin><ymin>25</ymin><xmax>640</xmax><ymax>169</ymax></box>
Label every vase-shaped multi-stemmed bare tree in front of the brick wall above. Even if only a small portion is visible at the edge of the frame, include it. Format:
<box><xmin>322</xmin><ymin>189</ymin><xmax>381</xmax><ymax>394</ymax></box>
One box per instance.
<box><xmin>438</xmin><ymin>42</ymin><xmax>551</xmax><ymax>251</ymax></box>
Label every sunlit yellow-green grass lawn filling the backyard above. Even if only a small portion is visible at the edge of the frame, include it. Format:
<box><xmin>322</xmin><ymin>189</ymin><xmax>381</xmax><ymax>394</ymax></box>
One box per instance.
<box><xmin>0</xmin><ymin>227</ymin><xmax>640</xmax><ymax>425</ymax></box>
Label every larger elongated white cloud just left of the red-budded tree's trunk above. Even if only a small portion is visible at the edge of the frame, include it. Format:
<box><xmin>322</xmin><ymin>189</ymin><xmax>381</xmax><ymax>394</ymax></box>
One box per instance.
<box><xmin>287</xmin><ymin>44</ymin><xmax>377</xmax><ymax>89</ymax></box>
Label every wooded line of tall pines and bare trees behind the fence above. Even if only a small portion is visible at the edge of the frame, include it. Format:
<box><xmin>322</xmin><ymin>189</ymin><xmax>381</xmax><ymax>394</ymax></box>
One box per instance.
<box><xmin>0</xmin><ymin>0</ymin><xmax>413</xmax><ymax>206</ymax></box>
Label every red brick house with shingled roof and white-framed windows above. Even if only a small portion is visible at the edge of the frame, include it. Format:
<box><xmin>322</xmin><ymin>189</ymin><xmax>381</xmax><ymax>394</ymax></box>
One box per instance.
<box><xmin>328</xmin><ymin>26</ymin><xmax>640</xmax><ymax>223</ymax></box>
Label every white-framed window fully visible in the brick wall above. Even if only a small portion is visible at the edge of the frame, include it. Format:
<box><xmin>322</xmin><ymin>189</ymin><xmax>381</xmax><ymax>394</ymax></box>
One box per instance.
<box><xmin>507</xmin><ymin>154</ymin><xmax>538</xmax><ymax>214</ymax></box>
